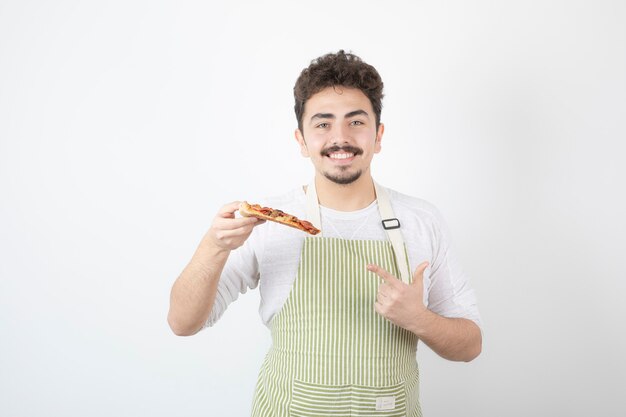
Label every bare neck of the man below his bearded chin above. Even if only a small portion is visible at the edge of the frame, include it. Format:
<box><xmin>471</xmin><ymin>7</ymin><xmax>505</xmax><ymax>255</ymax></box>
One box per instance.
<box><xmin>315</xmin><ymin>172</ymin><xmax>376</xmax><ymax>211</ymax></box>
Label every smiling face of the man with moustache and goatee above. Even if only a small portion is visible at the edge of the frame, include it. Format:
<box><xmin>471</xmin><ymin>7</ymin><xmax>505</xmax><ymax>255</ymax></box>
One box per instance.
<box><xmin>296</xmin><ymin>86</ymin><xmax>384</xmax><ymax>185</ymax></box>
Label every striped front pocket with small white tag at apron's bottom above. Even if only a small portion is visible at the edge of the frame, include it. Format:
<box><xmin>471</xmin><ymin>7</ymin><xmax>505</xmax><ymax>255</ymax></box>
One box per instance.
<box><xmin>289</xmin><ymin>380</ymin><xmax>406</xmax><ymax>417</ymax></box>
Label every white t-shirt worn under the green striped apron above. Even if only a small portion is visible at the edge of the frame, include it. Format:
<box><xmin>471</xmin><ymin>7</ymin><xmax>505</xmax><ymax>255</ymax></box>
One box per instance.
<box><xmin>206</xmin><ymin>188</ymin><xmax>480</xmax><ymax>326</ymax></box>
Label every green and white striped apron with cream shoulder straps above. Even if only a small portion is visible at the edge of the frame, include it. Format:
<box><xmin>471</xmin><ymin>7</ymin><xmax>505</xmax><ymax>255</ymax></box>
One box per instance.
<box><xmin>252</xmin><ymin>180</ymin><xmax>422</xmax><ymax>417</ymax></box>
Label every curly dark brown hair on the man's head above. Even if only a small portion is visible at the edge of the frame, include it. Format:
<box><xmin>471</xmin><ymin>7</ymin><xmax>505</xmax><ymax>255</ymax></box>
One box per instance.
<box><xmin>293</xmin><ymin>50</ymin><xmax>383</xmax><ymax>131</ymax></box>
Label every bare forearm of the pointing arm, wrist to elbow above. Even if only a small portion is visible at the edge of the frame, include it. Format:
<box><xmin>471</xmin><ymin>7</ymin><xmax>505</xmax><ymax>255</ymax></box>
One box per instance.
<box><xmin>409</xmin><ymin>310</ymin><xmax>482</xmax><ymax>362</ymax></box>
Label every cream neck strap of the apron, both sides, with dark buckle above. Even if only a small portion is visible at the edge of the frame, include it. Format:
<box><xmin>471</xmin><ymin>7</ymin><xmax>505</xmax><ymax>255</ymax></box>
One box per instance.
<box><xmin>306</xmin><ymin>181</ymin><xmax>411</xmax><ymax>284</ymax></box>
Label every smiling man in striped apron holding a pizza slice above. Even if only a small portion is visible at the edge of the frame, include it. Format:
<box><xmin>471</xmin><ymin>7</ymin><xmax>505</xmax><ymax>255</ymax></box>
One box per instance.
<box><xmin>168</xmin><ymin>51</ymin><xmax>482</xmax><ymax>416</ymax></box>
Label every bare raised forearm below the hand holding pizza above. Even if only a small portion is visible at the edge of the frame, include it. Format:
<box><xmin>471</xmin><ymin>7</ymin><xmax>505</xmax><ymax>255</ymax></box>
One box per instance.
<box><xmin>167</xmin><ymin>240</ymin><xmax>230</xmax><ymax>336</ymax></box>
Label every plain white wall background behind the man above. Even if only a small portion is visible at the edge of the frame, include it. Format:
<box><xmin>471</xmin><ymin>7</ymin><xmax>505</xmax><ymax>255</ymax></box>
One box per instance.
<box><xmin>0</xmin><ymin>0</ymin><xmax>626</xmax><ymax>417</ymax></box>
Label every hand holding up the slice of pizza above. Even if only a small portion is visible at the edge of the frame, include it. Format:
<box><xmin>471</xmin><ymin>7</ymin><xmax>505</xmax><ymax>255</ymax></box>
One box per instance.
<box><xmin>204</xmin><ymin>201</ymin><xmax>265</xmax><ymax>251</ymax></box>
